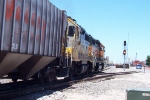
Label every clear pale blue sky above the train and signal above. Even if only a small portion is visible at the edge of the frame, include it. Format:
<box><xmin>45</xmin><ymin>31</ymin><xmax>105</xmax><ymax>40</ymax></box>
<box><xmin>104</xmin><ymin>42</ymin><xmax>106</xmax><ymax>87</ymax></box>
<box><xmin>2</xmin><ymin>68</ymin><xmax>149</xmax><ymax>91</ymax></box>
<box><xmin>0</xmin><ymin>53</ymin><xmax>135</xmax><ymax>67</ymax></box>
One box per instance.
<box><xmin>50</xmin><ymin>0</ymin><xmax>150</xmax><ymax>63</ymax></box>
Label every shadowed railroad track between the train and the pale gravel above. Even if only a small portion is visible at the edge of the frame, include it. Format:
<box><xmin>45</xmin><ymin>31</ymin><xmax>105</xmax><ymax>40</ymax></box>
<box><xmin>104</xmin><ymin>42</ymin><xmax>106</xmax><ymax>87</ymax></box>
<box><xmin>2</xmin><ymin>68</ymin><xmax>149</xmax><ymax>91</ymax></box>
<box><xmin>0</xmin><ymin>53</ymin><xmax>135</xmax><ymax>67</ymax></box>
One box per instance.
<box><xmin>0</xmin><ymin>71</ymin><xmax>138</xmax><ymax>100</ymax></box>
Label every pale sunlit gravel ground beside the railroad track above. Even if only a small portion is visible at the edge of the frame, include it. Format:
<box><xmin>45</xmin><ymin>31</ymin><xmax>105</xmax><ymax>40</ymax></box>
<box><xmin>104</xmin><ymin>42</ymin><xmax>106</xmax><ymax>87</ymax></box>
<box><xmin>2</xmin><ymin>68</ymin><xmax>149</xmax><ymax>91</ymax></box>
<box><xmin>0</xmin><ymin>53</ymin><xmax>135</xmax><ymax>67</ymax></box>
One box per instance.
<box><xmin>13</xmin><ymin>68</ymin><xmax>150</xmax><ymax>100</ymax></box>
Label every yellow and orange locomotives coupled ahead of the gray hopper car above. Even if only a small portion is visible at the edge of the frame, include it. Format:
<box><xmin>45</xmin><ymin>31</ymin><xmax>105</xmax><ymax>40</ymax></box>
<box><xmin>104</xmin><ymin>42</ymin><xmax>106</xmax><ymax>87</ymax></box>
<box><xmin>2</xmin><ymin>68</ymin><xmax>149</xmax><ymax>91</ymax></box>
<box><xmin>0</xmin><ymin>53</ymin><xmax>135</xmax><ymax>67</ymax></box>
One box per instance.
<box><xmin>62</xmin><ymin>17</ymin><xmax>103</xmax><ymax>75</ymax></box>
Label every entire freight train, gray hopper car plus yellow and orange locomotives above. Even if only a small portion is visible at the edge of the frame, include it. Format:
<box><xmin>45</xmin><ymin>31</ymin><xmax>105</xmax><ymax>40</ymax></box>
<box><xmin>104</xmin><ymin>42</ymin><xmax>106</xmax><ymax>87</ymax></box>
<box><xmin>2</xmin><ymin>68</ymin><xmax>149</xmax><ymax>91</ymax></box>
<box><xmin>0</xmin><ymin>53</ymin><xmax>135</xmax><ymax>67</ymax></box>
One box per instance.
<box><xmin>0</xmin><ymin>0</ymin><xmax>105</xmax><ymax>82</ymax></box>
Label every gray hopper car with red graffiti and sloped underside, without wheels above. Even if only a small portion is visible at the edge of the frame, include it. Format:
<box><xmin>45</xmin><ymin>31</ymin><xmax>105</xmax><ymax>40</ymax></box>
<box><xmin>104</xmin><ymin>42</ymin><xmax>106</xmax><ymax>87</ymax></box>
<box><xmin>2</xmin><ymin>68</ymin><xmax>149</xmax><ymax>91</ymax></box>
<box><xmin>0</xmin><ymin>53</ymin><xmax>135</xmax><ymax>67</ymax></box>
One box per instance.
<box><xmin>0</xmin><ymin>0</ymin><xmax>67</xmax><ymax>78</ymax></box>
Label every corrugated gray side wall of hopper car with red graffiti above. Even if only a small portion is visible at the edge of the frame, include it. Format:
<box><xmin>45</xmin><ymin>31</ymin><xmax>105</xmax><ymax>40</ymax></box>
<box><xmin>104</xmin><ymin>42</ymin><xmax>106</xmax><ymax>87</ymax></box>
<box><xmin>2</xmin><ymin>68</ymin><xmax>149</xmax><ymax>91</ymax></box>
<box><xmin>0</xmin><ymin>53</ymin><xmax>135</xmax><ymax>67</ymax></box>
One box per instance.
<box><xmin>0</xmin><ymin>0</ymin><xmax>67</xmax><ymax>57</ymax></box>
